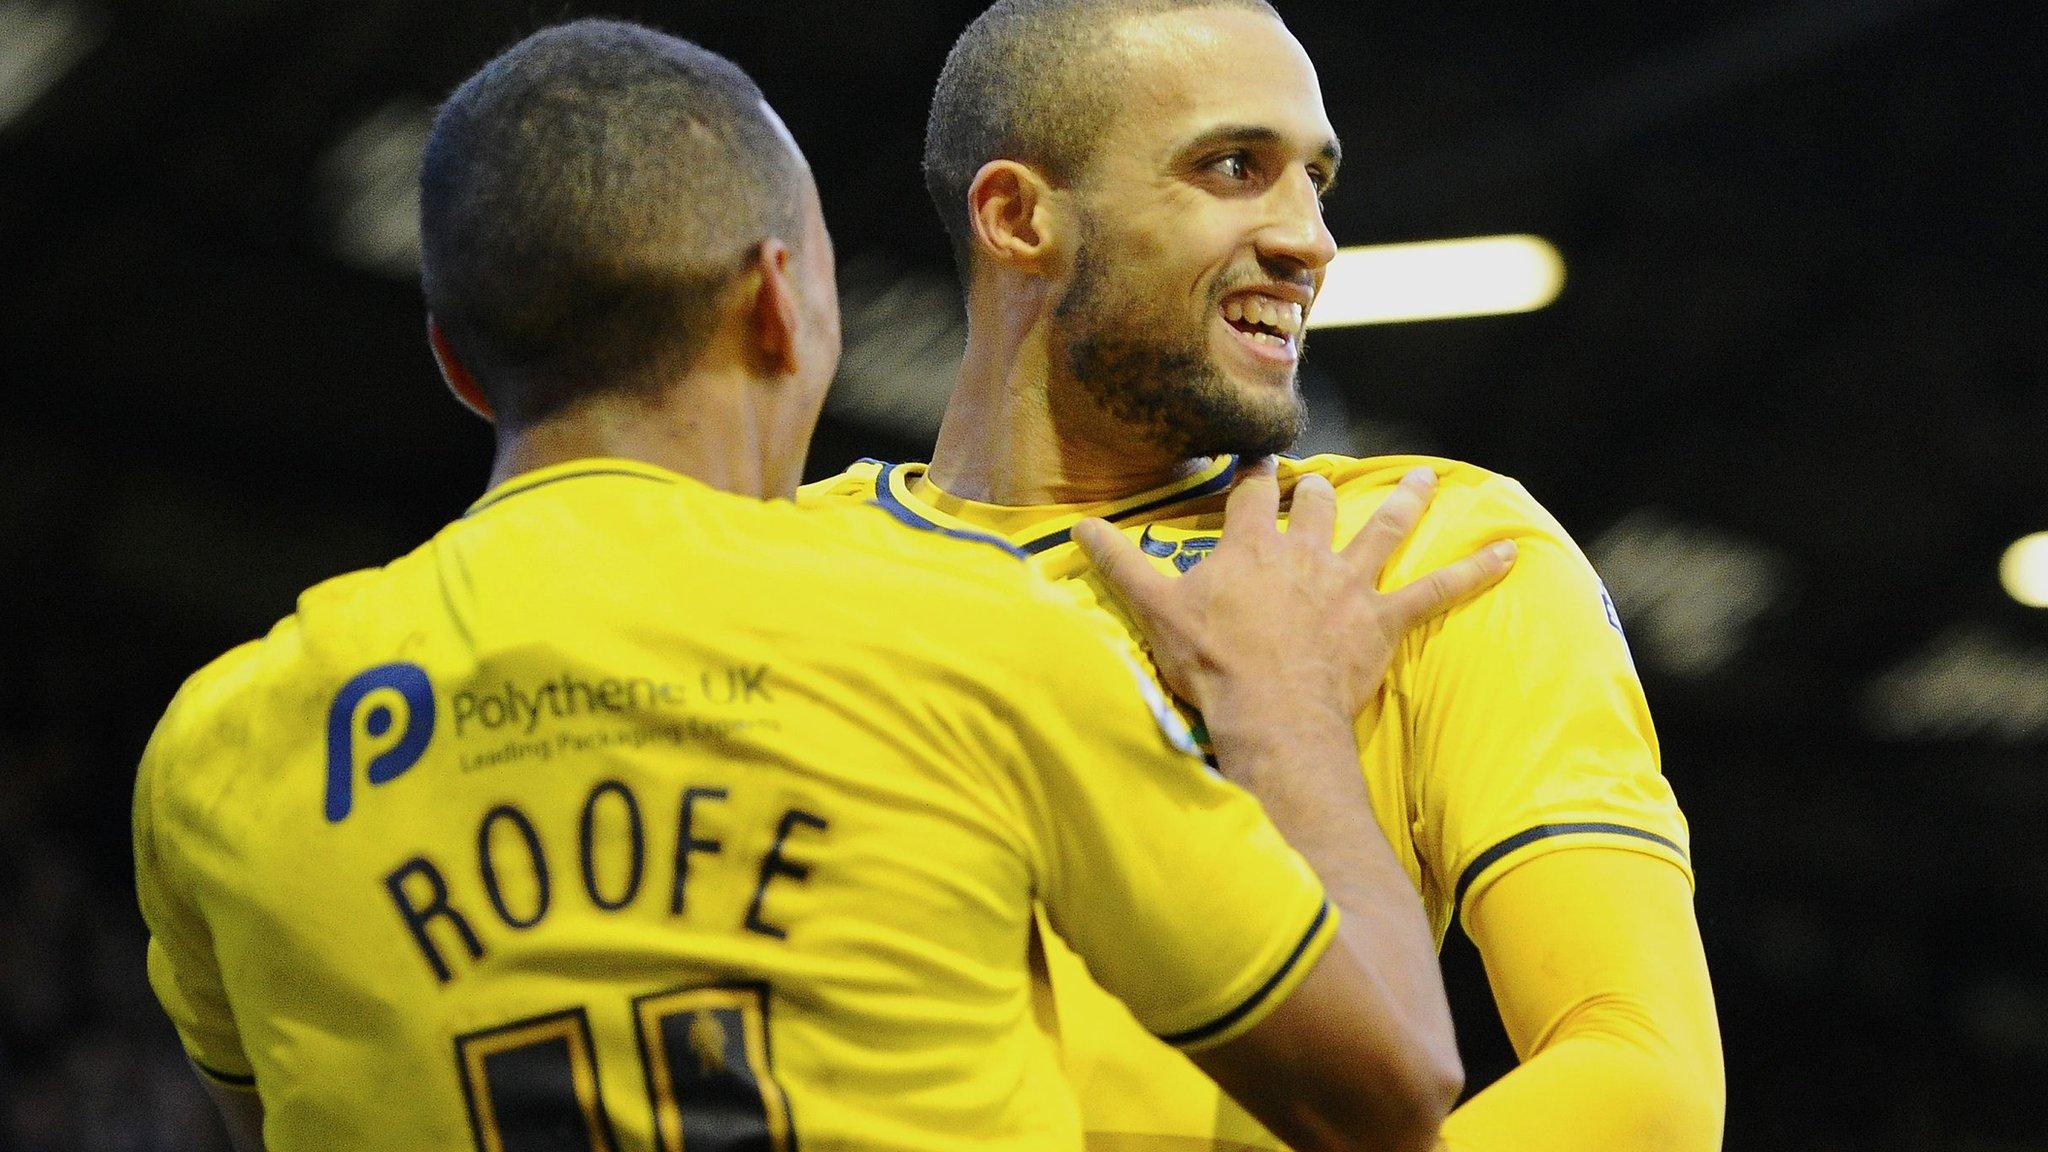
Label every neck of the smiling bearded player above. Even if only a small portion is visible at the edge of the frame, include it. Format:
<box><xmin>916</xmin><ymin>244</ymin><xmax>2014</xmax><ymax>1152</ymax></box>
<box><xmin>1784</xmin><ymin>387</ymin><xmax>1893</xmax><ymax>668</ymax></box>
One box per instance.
<box><xmin>928</xmin><ymin>297</ymin><xmax>1204</xmax><ymax>508</ymax></box>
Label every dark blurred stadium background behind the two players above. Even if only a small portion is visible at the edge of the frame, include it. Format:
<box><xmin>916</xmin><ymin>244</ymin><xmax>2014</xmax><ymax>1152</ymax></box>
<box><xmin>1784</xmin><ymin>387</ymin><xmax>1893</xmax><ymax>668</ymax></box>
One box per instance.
<box><xmin>0</xmin><ymin>0</ymin><xmax>2048</xmax><ymax>1152</ymax></box>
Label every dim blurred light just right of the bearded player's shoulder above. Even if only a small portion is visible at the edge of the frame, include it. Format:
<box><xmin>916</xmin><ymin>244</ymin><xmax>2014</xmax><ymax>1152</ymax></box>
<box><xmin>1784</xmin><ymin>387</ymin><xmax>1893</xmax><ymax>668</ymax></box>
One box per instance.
<box><xmin>1585</xmin><ymin>508</ymin><xmax>1786</xmax><ymax>678</ymax></box>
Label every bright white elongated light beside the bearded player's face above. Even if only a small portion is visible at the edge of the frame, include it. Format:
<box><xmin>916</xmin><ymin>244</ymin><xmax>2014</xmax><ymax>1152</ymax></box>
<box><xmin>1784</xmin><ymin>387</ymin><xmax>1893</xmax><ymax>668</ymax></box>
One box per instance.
<box><xmin>1309</xmin><ymin>236</ymin><xmax>1565</xmax><ymax>328</ymax></box>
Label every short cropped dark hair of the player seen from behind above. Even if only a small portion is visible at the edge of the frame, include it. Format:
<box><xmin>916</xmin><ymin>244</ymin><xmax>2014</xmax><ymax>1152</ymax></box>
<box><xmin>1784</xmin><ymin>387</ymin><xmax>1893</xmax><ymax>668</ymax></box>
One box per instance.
<box><xmin>420</xmin><ymin>20</ymin><xmax>805</xmax><ymax>426</ymax></box>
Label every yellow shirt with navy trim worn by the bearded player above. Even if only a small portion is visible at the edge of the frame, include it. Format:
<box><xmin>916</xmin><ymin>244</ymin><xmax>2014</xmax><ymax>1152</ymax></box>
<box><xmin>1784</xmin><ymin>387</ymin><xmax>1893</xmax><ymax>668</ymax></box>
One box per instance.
<box><xmin>799</xmin><ymin>455</ymin><xmax>1692</xmax><ymax>1152</ymax></box>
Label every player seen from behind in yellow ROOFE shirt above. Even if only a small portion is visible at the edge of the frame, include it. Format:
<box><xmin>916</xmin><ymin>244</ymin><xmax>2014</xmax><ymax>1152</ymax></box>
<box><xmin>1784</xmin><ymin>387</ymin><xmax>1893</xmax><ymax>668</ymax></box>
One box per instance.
<box><xmin>135</xmin><ymin>20</ymin><xmax>1509</xmax><ymax>1152</ymax></box>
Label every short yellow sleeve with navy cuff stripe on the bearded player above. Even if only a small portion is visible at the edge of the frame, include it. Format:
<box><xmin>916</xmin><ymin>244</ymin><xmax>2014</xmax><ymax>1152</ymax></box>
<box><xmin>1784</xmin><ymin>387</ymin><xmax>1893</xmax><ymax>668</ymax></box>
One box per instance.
<box><xmin>1354</xmin><ymin>461</ymin><xmax>1692</xmax><ymax>910</ymax></box>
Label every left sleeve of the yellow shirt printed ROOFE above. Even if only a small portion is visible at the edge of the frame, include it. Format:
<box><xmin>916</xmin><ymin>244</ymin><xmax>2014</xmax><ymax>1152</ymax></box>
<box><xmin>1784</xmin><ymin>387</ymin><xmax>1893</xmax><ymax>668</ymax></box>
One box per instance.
<box><xmin>133</xmin><ymin>654</ymin><xmax>256</xmax><ymax>1088</ymax></box>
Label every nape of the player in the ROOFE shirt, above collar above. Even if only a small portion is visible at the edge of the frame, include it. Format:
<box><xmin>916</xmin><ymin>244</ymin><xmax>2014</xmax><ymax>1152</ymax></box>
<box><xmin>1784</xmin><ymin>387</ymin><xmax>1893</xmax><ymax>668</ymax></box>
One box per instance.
<box><xmin>492</xmin><ymin>379</ymin><xmax>803</xmax><ymax>500</ymax></box>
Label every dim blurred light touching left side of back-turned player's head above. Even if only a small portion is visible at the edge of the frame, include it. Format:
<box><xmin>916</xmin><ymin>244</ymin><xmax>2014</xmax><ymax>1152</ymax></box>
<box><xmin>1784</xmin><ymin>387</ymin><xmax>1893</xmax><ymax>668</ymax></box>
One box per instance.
<box><xmin>319</xmin><ymin>96</ymin><xmax>434</xmax><ymax>281</ymax></box>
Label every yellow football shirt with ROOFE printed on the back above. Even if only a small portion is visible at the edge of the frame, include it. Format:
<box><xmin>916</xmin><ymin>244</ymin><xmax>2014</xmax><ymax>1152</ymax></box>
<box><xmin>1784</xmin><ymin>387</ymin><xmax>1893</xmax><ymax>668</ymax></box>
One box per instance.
<box><xmin>135</xmin><ymin>459</ymin><xmax>1335</xmax><ymax>1152</ymax></box>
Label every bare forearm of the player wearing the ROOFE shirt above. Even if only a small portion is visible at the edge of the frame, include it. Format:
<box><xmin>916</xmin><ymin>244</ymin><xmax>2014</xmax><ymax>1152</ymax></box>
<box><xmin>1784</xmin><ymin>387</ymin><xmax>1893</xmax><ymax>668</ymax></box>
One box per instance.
<box><xmin>1204</xmin><ymin>699</ymin><xmax>1464</xmax><ymax>1115</ymax></box>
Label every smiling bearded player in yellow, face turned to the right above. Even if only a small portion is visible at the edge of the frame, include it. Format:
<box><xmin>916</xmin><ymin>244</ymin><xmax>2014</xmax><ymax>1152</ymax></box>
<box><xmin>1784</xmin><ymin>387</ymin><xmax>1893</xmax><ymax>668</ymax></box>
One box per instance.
<box><xmin>803</xmin><ymin>0</ymin><xmax>1724</xmax><ymax>1152</ymax></box>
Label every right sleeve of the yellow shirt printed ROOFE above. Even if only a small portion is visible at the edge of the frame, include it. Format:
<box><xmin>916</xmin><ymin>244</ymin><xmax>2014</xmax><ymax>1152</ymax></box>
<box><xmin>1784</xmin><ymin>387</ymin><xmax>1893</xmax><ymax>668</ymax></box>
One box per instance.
<box><xmin>1024</xmin><ymin>609</ymin><xmax>1337</xmax><ymax>1050</ymax></box>
